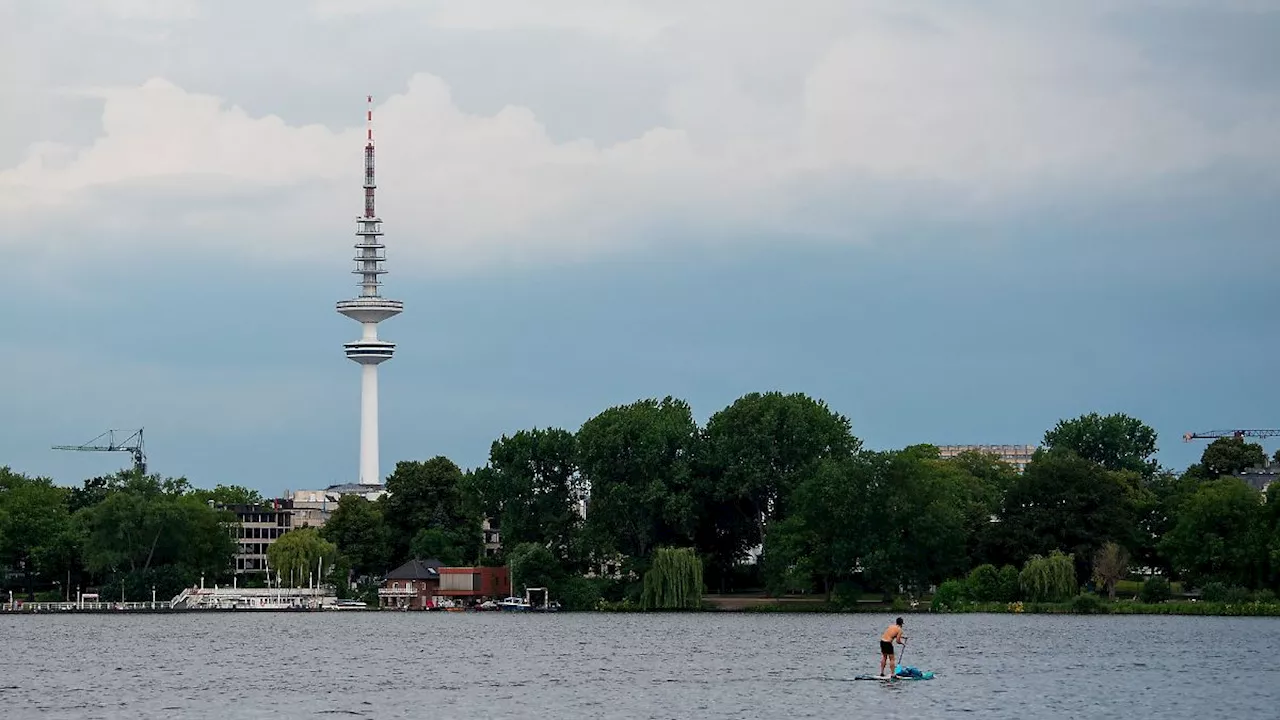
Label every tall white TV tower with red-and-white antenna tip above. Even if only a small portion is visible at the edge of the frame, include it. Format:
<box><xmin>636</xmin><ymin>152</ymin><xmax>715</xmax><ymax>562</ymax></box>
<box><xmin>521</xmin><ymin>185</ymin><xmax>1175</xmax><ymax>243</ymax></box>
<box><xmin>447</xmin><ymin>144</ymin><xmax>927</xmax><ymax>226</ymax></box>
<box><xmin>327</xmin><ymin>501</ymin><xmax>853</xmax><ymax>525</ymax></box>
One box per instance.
<box><xmin>338</xmin><ymin>96</ymin><xmax>404</xmax><ymax>486</ymax></box>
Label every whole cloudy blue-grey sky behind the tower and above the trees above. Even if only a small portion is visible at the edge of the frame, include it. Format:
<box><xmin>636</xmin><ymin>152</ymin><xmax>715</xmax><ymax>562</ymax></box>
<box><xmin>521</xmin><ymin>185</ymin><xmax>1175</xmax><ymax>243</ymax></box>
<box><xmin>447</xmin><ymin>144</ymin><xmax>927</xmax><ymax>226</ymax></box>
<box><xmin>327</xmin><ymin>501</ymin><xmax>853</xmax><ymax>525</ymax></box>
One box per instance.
<box><xmin>0</xmin><ymin>0</ymin><xmax>1280</xmax><ymax>493</ymax></box>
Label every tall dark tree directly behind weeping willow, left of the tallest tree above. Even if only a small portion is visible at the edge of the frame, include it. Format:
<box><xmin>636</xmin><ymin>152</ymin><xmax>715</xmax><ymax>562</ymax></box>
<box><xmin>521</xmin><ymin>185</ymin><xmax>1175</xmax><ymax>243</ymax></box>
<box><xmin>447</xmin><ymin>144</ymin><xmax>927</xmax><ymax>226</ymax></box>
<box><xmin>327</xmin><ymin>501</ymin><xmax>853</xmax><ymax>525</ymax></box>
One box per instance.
<box><xmin>577</xmin><ymin>397</ymin><xmax>699</xmax><ymax>561</ymax></box>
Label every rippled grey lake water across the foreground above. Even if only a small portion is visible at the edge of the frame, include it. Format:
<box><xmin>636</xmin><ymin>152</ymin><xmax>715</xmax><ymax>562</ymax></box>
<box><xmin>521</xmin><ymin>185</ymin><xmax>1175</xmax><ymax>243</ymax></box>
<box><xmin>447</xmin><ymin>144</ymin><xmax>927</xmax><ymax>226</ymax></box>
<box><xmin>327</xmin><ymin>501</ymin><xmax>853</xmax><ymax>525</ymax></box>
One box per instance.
<box><xmin>0</xmin><ymin>612</ymin><xmax>1280</xmax><ymax>720</ymax></box>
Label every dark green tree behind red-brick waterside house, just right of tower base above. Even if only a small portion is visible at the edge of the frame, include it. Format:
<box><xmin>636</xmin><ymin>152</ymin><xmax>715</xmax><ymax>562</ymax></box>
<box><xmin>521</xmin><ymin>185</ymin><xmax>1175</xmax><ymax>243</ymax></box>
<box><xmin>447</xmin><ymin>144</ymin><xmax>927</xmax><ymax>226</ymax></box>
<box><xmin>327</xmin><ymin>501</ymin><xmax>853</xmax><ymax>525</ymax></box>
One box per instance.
<box><xmin>380</xmin><ymin>456</ymin><xmax>483</xmax><ymax>562</ymax></box>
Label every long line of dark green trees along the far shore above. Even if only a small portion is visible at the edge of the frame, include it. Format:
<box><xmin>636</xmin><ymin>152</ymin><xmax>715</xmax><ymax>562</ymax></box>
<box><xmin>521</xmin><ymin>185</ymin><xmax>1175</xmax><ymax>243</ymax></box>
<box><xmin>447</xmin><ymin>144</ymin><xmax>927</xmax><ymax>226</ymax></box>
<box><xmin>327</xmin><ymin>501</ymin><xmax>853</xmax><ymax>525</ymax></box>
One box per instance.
<box><xmin>0</xmin><ymin>392</ymin><xmax>1280</xmax><ymax>607</ymax></box>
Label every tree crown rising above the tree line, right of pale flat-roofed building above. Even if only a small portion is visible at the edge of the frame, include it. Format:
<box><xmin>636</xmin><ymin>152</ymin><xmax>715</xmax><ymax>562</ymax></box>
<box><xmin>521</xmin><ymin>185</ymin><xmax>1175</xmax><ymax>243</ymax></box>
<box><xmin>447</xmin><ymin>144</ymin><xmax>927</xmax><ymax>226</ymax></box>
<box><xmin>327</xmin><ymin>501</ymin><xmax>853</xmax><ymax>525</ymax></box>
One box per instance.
<box><xmin>1044</xmin><ymin>413</ymin><xmax>1158</xmax><ymax>478</ymax></box>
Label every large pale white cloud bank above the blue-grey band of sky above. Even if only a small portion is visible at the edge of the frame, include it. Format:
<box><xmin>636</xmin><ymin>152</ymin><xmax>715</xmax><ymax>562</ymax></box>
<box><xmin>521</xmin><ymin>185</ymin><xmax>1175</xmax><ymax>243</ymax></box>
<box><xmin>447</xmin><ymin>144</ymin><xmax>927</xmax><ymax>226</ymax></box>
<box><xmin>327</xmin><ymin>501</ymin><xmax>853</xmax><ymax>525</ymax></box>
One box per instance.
<box><xmin>0</xmin><ymin>0</ymin><xmax>1280</xmax><ymax>273</ymax></box>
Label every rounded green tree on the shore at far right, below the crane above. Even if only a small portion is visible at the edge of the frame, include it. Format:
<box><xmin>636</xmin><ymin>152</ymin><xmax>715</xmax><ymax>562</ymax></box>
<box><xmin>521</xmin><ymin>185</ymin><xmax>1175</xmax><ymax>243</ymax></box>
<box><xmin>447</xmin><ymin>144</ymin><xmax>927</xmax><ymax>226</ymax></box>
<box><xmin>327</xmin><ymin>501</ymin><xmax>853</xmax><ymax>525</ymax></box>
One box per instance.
<box><xmin>1162</xmin><ymin>477</ymin><xmax>1268</xmax><ymax>588</ymax></box>
